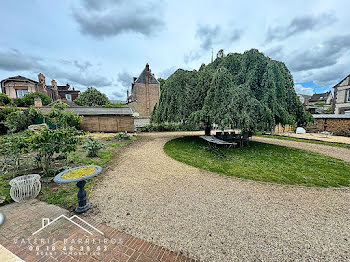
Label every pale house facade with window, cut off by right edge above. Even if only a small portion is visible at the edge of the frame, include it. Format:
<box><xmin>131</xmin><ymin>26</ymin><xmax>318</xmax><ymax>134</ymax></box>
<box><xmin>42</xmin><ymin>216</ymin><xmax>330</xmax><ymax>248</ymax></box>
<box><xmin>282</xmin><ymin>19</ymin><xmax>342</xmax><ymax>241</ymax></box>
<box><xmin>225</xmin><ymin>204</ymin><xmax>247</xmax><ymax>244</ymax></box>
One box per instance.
<box><xmin>333</xmin><ymin>75</ymin><xmax>350</xmax><ymax>114</ymax></box>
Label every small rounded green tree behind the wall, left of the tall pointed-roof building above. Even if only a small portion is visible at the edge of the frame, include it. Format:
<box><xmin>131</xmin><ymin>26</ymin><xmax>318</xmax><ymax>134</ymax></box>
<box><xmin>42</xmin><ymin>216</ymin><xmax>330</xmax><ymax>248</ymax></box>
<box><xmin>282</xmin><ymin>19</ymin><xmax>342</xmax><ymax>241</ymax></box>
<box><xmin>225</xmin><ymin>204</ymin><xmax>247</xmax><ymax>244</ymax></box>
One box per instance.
<box><xmin>74</xmin><ymin>87</ymin><xmax>110</xmax><ymax>106</ymax></box>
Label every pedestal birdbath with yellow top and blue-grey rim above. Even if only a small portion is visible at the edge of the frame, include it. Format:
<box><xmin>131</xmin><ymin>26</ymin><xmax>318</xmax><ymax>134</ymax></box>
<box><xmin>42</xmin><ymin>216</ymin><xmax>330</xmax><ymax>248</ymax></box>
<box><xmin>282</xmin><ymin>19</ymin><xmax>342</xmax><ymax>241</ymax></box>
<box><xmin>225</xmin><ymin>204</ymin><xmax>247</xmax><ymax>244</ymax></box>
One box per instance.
<box><xmin>53</xmin><ymin>165</ymin><xmax>102</xmax><ymax>214</ymax></box>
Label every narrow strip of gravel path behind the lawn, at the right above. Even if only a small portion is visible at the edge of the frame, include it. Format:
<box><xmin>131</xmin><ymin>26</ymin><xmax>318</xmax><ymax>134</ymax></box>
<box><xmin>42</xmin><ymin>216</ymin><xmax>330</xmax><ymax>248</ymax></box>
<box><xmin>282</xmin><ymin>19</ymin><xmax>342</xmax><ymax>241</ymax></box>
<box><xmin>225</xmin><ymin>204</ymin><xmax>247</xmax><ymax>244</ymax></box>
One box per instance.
<box><xmin>253</xmin><ymin>136</ymin><xmax>350</xmax><ymax>162</ymax></box>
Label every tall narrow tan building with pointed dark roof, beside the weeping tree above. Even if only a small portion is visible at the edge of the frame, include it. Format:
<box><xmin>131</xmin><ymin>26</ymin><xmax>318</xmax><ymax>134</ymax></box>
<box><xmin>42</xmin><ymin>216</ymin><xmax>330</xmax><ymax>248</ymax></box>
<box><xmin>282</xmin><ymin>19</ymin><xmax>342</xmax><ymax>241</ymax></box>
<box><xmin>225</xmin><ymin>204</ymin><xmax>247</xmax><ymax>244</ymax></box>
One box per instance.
<box><xmin>126</xmin><ymin>64</ymin><xmax>160</xmax><ymax>127</ymax></box>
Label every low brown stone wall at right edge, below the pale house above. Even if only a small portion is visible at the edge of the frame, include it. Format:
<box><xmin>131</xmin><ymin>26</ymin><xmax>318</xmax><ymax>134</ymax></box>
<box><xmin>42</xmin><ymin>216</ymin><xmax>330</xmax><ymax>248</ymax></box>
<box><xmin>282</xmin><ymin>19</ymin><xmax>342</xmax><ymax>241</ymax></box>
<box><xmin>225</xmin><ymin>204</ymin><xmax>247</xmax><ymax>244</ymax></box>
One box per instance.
<box><xmin>306</xmin><ymin>118</ymin><xmax>350</xmax><ymax>136</ymax></box>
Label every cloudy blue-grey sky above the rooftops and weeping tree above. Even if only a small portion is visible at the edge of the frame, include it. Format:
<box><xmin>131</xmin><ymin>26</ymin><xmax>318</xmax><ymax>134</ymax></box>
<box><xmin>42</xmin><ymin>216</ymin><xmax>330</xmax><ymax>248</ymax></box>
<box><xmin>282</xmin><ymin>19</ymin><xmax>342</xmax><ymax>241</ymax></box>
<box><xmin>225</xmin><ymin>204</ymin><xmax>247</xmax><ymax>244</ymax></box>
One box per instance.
<box><xmin>0</xmin><ymin>0</ymin><xmax>350</xmax><ymax>100</ymax></box>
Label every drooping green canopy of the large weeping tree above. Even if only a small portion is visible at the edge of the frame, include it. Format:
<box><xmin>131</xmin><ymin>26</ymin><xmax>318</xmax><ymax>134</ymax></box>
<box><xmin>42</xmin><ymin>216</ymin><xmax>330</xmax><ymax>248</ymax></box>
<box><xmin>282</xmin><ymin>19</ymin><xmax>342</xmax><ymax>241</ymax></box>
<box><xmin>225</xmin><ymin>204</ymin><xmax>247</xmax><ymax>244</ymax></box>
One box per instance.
<box><xmin>152</xmin><ymin>49</ymin><xmax>311</xmax><ymax>131</ymax></box>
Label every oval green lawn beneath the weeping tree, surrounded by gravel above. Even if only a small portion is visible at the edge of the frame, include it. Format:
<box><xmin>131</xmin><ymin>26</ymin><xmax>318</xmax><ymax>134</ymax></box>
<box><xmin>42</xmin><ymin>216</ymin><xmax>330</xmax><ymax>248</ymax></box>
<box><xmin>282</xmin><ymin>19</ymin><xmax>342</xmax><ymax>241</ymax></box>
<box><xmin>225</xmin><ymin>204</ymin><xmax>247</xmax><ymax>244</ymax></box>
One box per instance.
<box><xmin>164</xmin><ymin>137</ymin><xmax>350</xmax><ymax>187</ymax></box>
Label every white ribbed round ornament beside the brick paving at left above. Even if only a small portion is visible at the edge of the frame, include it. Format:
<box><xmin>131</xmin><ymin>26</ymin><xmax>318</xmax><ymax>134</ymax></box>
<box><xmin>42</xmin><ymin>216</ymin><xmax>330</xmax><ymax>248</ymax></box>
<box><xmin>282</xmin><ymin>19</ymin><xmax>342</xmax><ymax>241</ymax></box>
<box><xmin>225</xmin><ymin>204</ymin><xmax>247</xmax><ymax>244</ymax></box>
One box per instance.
<box><xmin>10</xmin><ymin>174</ymin><xmax>41</xmax><ymax>202</ymax></box>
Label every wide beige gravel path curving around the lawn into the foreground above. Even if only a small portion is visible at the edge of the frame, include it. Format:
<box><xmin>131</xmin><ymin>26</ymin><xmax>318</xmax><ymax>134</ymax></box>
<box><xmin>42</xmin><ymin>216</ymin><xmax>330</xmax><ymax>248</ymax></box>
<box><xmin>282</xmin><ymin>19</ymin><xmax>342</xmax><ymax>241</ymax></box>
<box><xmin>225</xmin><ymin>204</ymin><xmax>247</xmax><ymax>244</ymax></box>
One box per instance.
<box><xmin>90</xmin><ymin>133</ymin><xmax>350</xmax><ymax>261</ymax></box>
